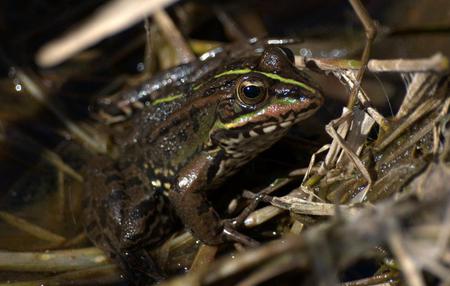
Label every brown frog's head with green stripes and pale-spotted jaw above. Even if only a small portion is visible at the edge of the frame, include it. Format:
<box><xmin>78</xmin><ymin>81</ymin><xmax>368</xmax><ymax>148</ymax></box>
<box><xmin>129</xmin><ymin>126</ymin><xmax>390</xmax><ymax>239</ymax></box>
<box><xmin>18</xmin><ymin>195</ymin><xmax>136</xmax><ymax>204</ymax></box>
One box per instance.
<box><xmin>210</xmin><ymin>47</ymin><xmax>323</xmax><ymax>157</ymax></box>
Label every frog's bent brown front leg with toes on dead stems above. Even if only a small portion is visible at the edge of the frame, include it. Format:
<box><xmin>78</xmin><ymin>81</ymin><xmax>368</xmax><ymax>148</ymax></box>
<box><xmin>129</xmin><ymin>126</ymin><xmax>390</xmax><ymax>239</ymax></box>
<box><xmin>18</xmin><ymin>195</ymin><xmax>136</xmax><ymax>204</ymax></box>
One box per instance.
<box><xmin>169</xmin><ymin>152</ymin><xmax>257</xmax><ymax>245</ymax></box>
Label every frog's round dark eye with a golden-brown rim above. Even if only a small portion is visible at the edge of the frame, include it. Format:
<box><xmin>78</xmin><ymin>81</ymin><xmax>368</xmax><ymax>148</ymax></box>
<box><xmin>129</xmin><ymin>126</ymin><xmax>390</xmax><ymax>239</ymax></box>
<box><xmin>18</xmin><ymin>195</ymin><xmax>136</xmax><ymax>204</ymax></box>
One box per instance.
<box><xmin>237</xmin><ymin>79</ymin><xmax>267</xmax><ymax>105</ymax></box>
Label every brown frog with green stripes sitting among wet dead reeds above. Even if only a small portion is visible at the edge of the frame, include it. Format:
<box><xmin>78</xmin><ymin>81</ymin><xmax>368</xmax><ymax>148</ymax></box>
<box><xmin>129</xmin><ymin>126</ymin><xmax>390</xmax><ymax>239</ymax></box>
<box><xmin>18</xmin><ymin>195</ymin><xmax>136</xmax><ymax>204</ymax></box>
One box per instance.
<box><xmin>85</xmin><ymin>46</ymin><xmax>323</xmax><ymax>284</ymax></box>
